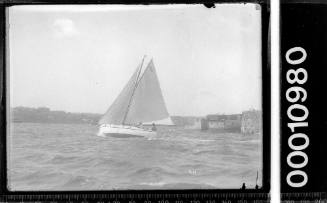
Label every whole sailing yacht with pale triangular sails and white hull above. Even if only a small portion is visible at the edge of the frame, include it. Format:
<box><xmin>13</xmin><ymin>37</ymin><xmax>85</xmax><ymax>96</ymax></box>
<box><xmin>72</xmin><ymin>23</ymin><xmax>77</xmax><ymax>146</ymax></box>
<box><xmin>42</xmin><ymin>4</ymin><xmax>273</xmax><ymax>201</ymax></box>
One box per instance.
<box><xmin>98</xmin><ymin>57</ymin><xmax>173</xmax><ymax>137</ymax></box>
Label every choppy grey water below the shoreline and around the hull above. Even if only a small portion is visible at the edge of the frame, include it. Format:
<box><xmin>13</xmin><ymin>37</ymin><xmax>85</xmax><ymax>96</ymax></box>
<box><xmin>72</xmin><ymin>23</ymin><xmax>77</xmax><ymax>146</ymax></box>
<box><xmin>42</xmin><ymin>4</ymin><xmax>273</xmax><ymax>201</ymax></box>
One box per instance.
<box><xmin>8</xmin><ymin>123</ymin><xmax>262</xmax><ymax>190</ymax></box>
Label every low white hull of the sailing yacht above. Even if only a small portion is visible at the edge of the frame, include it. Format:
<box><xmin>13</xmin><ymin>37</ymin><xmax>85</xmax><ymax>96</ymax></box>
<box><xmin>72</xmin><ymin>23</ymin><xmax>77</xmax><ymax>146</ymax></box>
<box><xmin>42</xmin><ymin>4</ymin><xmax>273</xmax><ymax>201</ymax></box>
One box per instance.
<box><xmin>98</xmin><ymin>124</ymin><xmax>157</xmax><ymax>138</ymax></box>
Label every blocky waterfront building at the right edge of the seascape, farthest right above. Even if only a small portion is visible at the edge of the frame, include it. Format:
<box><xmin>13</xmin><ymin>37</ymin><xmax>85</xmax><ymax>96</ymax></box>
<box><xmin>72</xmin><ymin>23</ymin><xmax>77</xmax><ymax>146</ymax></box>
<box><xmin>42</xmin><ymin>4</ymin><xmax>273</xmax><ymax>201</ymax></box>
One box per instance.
<box><xmin>241</xmin><ymin>110</ymin><xmax>262</xmax><ymax>134</ymax></box>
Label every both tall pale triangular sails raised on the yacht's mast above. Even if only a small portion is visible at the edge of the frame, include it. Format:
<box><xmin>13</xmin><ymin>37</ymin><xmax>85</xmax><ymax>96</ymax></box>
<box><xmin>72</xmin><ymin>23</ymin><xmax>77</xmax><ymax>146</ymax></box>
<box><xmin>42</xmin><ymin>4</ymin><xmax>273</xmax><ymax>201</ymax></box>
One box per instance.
<box><xmin>99</xmin><ymin>59</ymin><xmax>170</xmax><ymax>125</ymax></box>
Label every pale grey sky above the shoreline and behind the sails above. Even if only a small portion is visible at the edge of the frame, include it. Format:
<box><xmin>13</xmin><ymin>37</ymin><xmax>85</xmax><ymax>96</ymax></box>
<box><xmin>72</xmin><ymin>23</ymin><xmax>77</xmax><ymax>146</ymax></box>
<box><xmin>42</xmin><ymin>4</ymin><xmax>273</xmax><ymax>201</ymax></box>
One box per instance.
<box><xmin>7</xmin><ymin>4</ymin><xmax>262</xmax><ymax>116</ymax></box>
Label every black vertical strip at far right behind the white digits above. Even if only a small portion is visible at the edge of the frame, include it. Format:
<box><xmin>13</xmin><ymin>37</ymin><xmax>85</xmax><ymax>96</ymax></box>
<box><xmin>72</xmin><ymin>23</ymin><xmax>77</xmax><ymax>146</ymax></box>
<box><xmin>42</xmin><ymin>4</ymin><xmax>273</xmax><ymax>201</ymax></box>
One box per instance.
<box><xmin>280</xmin><ymin>0</ymin><xmax>327</xmax><ymax>202</ymax></box>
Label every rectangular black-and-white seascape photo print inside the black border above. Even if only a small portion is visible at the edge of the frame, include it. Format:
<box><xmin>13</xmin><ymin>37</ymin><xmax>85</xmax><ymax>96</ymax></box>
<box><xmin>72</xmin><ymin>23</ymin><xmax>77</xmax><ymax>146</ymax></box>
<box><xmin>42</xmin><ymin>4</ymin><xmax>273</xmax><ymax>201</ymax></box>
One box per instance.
<box><xmin>6</xmin><ymin>3</ymin><xmax>269</xmax><ymax>191</ymax></box>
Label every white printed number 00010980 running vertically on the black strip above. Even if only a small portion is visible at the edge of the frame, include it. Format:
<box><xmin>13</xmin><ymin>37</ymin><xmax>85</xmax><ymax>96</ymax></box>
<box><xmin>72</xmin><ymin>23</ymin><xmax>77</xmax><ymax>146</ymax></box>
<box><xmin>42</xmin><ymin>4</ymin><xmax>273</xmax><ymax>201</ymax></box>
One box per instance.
<box><xmin>286</xmin><ymin>47</ymin><xmax>309</xmax><ymax>188</ymax></box>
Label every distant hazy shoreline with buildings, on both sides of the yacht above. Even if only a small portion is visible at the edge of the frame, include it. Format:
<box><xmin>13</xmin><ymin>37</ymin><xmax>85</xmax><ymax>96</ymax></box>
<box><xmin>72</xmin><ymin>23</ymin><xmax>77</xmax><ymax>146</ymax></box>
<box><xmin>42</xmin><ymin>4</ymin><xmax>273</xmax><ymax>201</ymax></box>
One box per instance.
<box><xmin>10</xmin><ymin>107</ymin><xmax>262</xmax><ymax>134</ymax></box>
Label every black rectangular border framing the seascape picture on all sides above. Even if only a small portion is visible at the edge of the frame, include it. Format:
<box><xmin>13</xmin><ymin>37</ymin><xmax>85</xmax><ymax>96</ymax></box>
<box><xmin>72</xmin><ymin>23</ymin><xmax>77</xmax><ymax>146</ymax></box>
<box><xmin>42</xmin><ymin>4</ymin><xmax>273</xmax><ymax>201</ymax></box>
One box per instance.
<box><xmin>0</xmin><ymin>0</ymin><xmax>271</xmax><ymax>203</ymax></box>
